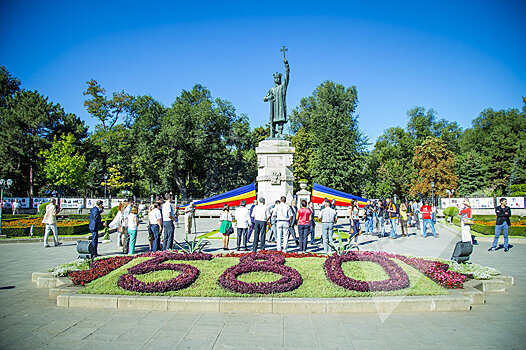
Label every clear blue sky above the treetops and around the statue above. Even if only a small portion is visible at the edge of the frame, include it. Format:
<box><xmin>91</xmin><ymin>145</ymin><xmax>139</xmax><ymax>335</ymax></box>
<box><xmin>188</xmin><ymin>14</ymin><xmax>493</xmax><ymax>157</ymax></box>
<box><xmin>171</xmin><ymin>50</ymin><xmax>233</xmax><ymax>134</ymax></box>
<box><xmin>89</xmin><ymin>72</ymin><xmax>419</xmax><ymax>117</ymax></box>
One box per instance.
<box><xmin>0</xmin><ymin>0</ymin><xmax>526</xmax><ymax>142</ymax></box>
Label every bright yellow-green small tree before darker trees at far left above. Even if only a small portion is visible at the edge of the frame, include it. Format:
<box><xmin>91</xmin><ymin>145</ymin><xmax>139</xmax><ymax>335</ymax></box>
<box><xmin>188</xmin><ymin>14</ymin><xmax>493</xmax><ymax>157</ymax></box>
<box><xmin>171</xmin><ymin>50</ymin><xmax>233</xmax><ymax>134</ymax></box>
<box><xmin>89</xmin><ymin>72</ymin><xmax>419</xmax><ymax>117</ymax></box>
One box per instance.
<box><xmin>39</xmin><ymin>134</ymin><xmax>86</xmax><ymax>189</ymax></box>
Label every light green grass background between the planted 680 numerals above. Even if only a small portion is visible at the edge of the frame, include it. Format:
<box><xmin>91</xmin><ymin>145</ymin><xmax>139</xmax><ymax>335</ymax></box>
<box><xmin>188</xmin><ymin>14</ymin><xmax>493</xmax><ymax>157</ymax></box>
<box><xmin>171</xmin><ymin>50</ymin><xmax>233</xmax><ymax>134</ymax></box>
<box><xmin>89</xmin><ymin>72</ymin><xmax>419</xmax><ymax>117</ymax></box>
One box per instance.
<box><xmin>79</xmin><ymin>257</ymin><xmax>448</xmax><ymax>298</ymax></box>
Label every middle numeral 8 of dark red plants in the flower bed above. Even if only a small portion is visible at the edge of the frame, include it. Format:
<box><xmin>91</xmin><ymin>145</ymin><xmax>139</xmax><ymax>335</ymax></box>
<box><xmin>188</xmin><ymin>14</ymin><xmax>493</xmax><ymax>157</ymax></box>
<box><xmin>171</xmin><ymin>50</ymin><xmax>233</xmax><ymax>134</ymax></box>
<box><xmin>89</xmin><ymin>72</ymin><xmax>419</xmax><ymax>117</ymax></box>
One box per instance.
<box><xmin>219</xmin><ymin>253</ymin><xmax>303</xmax><ymax>294</ymax></box>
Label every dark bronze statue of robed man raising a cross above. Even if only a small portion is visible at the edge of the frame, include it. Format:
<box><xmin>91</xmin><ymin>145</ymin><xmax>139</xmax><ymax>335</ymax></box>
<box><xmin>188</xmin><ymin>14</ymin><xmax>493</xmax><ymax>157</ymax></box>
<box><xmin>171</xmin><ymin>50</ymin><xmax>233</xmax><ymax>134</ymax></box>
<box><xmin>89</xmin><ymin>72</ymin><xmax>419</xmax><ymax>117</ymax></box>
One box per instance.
<box><xmin>263</xmin><ymin>58</ymin><xmax>290</xmax><ymax>139</ymax></box>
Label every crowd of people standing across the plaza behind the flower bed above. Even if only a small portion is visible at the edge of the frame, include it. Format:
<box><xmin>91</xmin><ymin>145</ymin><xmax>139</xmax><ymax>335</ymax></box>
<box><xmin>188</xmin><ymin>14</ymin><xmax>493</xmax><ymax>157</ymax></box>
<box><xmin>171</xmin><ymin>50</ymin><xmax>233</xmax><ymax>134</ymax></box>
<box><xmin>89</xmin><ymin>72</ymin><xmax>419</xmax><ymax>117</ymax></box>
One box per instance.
<box><xmin>36</xmin><ymin>194</ymin><xmax>511</xmax><ymax>256</ymax></box>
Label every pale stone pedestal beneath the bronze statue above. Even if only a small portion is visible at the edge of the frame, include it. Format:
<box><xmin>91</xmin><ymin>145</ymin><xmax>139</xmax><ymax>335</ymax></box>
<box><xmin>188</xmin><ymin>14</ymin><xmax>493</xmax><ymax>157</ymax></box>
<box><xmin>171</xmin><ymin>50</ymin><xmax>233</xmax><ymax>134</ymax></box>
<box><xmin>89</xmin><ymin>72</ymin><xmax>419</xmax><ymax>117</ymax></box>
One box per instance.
<box><xmin>256</xmin><ymin>140</ymin><xmax>295</xmax><ymax>205</ymax></box>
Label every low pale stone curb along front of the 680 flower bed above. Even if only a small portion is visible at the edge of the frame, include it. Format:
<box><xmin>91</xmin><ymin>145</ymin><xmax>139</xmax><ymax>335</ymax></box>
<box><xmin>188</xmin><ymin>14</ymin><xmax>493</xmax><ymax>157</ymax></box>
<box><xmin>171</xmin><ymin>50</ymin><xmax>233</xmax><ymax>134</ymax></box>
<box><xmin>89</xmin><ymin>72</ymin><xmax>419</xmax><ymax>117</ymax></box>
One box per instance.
<box><xmin>31</xmin><ymin>272</ymin><xmax>514</xmax><ymax>314</ymax></box>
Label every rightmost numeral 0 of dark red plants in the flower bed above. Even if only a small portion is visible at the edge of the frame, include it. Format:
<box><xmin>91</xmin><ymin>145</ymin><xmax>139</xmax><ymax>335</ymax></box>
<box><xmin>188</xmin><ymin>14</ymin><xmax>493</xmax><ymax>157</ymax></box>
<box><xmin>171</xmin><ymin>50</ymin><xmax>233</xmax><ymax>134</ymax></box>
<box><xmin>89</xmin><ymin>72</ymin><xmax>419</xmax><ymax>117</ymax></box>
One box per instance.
<box><xmin>324</xmin><ymin>252</ymin><xmax>409</xmax><ymax>292</ymax></box>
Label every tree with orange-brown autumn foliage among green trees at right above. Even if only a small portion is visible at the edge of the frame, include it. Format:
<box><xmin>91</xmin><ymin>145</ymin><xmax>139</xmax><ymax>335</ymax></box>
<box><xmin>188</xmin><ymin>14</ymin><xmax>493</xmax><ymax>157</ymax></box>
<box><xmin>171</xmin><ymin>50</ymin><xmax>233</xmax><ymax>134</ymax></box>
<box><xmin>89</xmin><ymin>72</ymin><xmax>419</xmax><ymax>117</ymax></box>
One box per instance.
<box><xmin>411</xmin><ymin>137</ymin><xmax>458</xmax><ymax>196</ymax></box>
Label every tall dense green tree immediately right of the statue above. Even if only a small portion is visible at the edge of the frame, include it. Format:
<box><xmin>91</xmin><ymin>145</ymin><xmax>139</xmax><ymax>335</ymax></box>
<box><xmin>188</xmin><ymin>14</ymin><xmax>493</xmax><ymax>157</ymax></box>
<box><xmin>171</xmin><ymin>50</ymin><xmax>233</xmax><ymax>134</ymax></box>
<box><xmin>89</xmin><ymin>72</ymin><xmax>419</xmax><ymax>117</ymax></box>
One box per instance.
<box><xmin>291</xmin><ymin>81</ymin><xmax>367</xmax><ymax>193</ymax></box>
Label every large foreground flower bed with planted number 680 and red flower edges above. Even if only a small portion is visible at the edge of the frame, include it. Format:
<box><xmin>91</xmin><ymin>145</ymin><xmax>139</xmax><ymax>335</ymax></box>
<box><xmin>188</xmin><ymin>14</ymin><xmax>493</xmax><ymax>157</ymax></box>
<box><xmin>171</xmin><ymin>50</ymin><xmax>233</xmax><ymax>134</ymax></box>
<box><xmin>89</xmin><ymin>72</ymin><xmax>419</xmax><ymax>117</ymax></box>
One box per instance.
<box><xmin>69</xmin><ymin>251</ymin><xmax>482</xmax><ymax>297</ymax></box>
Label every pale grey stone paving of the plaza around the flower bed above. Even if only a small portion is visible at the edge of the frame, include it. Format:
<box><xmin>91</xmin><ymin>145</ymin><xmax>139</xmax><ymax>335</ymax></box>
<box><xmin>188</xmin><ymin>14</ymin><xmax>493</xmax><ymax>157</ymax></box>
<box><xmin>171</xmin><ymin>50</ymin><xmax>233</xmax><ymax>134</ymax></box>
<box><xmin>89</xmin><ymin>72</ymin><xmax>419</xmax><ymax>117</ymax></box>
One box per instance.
<box><xmin>0</xmin><ymin>219</ymin><xmax>526</xmax><ymax>349</ymax></box>
